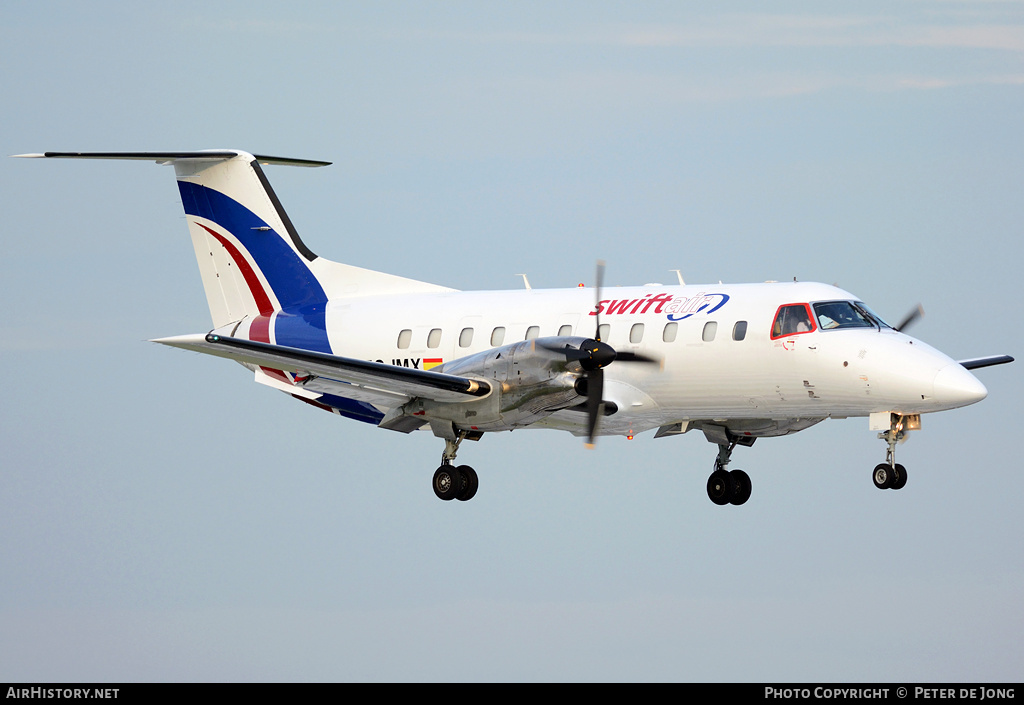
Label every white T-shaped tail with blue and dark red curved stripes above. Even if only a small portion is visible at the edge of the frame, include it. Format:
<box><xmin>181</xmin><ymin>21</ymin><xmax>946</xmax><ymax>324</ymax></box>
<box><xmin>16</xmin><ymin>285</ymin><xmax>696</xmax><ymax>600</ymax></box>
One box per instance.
<box><xmin>18</xmin><ymin>150</ymin><xmax>452</xmax><ymax>353</ymax></box>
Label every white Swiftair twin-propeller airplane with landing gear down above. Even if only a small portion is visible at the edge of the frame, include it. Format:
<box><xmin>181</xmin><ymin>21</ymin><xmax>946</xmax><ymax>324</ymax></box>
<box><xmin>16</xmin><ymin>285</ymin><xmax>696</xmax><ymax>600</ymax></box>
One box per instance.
<box><xmin>16</xmin><ymin>150</ymin><xmax>1014</xmax><ymax>505</ymax></box>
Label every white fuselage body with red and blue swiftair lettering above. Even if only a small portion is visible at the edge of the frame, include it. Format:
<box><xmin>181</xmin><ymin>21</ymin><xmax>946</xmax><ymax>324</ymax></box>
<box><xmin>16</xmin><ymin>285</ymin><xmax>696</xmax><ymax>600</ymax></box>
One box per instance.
<box><xmin>301</xmin><ymin>283</ymin><xmax>986</xmax><ymax>436</ymax></box>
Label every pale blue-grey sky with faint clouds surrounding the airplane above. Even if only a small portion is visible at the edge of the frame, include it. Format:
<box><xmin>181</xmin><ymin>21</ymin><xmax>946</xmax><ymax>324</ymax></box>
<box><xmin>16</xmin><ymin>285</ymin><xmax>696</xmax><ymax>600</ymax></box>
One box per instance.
<box><xmin>0</xmin><ymin>0</ymin><xmax>1024</xmax><ymax>681</ymax></box>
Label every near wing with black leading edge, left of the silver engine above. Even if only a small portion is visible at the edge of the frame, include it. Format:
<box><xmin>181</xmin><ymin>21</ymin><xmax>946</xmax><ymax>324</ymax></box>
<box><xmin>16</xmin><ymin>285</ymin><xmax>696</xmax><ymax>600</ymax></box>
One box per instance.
<box><xmin>153</xmin><ymin>333</ymin><xmax>490</xmax><ymax>407</ymax></box>
